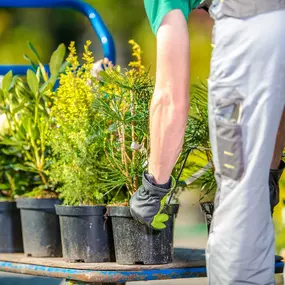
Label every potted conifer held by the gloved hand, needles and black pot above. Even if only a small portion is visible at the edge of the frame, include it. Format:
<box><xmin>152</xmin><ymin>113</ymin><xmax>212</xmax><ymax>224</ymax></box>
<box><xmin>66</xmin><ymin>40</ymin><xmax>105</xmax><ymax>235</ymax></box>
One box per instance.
<box><xmin>94</xmin><ymin>41</ymin><xmax>181</xmax><ymax>264</ymax></box>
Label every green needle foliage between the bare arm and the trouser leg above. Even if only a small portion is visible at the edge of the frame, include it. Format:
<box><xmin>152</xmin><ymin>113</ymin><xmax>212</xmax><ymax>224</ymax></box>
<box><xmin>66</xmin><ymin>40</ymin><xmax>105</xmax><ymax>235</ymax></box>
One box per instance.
<box><xmin>175</xmin><ymin>82</ymin><xmax>217</xmax><ymax>200</ymax></box>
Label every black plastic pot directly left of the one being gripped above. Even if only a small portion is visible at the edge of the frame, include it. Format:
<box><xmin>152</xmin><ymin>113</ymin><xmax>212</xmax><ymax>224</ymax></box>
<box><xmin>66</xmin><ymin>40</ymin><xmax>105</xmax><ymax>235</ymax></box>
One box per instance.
<box><xmin>56</xmin><ymin>205</ymin><xmax>115</xmax><ymax>262</ymax></box>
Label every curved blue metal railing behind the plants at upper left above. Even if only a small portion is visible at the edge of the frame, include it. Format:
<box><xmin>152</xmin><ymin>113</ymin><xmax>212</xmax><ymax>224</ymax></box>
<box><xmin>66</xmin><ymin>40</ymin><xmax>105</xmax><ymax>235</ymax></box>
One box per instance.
<box><xmin>0</xmin><ymin>0</ymin><xmax>116</xmax><ymax>75</ymax></box>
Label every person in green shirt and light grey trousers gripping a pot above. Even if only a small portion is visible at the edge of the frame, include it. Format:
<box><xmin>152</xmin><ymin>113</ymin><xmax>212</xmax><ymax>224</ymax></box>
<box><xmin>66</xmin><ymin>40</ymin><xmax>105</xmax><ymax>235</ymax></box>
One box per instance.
<box><xmin>130</xmin><ymin>0</ymin><xmax>285</xmax><ymax>285</ymax></box>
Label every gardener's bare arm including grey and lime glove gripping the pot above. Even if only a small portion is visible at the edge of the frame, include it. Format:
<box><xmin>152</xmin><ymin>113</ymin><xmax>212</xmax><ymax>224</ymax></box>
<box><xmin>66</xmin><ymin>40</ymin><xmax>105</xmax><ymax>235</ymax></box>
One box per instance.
<box><xmin>130</xmin><ymin>9</ymin><xmax>189</xmax><ymax>229</ymax></box>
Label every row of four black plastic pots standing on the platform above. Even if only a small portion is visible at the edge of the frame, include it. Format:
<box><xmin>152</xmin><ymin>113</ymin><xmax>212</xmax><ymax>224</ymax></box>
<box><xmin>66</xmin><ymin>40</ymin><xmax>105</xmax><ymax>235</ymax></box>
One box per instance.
<box><xmin>0</xmin><ymin>199</ymin><xmax>178</xmax><ymax>264</ymax></box>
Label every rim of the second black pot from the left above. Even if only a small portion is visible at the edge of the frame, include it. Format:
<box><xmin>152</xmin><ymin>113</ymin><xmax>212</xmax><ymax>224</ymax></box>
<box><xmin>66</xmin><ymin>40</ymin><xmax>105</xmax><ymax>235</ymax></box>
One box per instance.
<box><xmin>16</xmin><ymin>198</ymin><xmax>61</xmax><ymax>209</ymax></box>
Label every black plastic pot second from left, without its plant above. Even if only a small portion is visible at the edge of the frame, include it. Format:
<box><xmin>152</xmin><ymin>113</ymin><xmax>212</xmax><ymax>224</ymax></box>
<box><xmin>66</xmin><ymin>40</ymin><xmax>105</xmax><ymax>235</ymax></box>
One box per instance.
<box><xmin>17</xmin><ymin>198</ymin><xmax>62</xmax><ymax>257</ymax></box>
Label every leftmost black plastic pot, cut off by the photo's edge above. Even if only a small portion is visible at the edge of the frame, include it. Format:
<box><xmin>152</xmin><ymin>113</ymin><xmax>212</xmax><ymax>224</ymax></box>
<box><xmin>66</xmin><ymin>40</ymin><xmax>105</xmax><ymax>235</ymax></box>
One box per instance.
<box><xmin>0</xmin><ymin>202</ymin><xmax>23</xmax><ymax>253</ymax></box>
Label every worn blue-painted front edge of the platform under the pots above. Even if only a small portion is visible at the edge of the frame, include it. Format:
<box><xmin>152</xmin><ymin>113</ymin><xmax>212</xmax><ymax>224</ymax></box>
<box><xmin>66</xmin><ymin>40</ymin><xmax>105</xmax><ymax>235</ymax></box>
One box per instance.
<box><xmin>0</xmin><ymin>261</ymin><xmax>206</xmax><ymax>283</ymax></box>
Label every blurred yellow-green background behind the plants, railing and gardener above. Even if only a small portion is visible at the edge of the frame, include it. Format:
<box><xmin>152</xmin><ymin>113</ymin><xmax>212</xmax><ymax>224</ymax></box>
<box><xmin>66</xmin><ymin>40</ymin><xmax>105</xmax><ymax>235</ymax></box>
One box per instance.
<box><xmin>0</xmin><ymin>0</ymin><xmax>285</xmax><ymax>253</ymax></box>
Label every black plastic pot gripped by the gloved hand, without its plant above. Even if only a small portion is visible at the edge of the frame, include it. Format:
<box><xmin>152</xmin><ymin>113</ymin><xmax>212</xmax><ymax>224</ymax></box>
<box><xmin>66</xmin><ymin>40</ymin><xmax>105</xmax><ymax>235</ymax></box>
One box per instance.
<box><xmin>108</xmin><ymin>205</ymin><xmax>179</xmax><ymax>265</ymax></box>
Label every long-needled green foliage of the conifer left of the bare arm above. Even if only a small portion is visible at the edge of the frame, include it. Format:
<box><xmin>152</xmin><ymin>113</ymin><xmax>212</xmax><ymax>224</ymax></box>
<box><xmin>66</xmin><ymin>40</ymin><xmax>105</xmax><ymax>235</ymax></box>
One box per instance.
<box><xmin>93</xmin><ymin>40</ymin><xmax>154</xmax><ymax>203</ymax></box>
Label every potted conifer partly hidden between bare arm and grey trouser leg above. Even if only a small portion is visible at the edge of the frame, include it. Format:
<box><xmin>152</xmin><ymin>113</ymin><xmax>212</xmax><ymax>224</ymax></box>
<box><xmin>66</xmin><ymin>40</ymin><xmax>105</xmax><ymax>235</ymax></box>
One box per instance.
<box><xmin>181</xmin><ymin>82</ymin><xmax>217</xmax><ymax>232</ymax></box>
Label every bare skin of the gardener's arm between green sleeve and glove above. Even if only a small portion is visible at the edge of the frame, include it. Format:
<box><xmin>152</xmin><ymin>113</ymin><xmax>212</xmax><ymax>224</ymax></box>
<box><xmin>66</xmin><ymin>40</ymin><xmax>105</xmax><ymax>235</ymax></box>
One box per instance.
<box><xmin>146</xmin><ymin>10</ymin><xmax>190</xmax><ymax>184</ymax></box>
